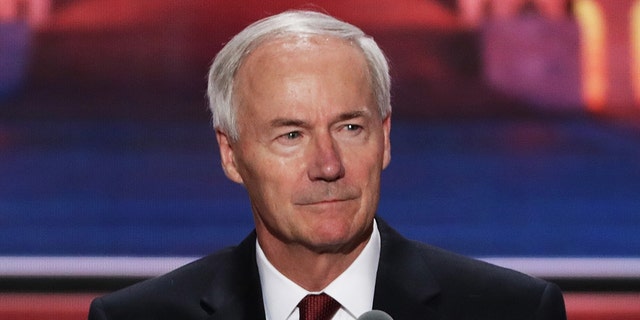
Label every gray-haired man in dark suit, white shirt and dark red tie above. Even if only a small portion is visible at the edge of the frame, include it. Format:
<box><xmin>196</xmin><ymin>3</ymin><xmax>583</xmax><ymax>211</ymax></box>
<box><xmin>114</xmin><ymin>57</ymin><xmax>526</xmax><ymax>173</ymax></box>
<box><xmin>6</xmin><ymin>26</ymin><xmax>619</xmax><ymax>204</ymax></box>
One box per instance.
<box><xmin>89</xmin><ymin>11</ymin><xmax>565</xmax><ymax>320</ymax></box>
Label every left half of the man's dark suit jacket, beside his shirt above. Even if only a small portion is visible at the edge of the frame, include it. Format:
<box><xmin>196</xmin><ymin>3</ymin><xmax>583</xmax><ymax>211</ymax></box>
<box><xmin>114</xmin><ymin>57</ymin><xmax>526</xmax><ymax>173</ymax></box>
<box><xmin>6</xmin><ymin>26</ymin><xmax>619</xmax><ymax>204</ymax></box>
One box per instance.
<box><xmin>89</xmin><ymin>234</ymin><xmax>264</xmax><ymax>320</ymax></box>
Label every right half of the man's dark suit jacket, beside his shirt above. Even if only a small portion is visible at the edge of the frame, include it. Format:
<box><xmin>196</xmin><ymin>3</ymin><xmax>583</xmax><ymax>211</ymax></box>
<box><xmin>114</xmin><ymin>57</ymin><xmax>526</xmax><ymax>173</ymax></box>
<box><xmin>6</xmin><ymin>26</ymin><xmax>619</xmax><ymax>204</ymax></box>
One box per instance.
<box><xmin>374</xmin><ymin>220</ymin><xmax>566</xmax><ymax>320</ymax></box>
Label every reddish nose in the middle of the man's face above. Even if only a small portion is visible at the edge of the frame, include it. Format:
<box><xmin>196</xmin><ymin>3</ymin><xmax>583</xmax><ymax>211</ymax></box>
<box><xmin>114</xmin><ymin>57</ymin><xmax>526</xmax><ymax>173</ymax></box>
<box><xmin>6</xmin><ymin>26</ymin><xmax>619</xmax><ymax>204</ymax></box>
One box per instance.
<box><xmin>308</xmin><ymin>135</ymin><xmax>344</xmax><ymax>182</ymax></box>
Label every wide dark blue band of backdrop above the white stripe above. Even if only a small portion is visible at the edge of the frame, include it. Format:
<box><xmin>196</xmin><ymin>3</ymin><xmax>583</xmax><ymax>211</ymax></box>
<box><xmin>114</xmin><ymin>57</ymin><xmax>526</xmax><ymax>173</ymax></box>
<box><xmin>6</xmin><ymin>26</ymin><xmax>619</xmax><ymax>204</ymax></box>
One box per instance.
<box><xmin>0</xmin><ymin>116</ymin><xmax>640</xmax><ymax>257</ymax></box>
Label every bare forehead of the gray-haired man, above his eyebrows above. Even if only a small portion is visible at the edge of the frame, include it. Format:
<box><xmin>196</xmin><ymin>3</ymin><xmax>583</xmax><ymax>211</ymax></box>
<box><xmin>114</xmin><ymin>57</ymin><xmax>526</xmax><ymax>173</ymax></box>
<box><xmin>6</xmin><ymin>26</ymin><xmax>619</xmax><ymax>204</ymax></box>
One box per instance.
<box><xmin>234</xmin><ymin>35</ymin><xmax>373</xmax><ymax>114</ymax></box>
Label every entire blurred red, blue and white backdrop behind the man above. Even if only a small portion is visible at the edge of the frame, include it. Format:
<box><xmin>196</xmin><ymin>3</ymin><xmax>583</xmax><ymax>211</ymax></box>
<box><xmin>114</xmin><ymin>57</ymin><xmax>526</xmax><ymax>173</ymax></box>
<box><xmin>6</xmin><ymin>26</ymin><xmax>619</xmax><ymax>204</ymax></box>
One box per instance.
<box><xmin>0</xmin><ymin>0</ymin><xmax>640</xmax><ymax>319</ymax></box>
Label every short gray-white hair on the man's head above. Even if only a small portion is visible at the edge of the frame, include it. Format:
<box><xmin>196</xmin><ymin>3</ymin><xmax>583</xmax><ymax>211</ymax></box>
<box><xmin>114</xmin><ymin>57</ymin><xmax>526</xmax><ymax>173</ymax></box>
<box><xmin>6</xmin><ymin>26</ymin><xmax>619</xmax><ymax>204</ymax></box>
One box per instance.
<box><xmin>207</xmin><ymin>11</ymin><xmax>391</xmax><ymax>141</ymax></box>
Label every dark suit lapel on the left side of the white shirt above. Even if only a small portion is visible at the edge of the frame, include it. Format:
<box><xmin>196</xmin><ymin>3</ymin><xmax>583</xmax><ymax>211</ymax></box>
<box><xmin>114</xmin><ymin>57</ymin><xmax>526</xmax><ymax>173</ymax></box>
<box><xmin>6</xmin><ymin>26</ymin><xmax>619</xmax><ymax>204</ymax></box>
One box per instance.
<box><xmin>200</xmin><ymin>232</ymin><xmax>265</xmax><ymax>320</ymax></box>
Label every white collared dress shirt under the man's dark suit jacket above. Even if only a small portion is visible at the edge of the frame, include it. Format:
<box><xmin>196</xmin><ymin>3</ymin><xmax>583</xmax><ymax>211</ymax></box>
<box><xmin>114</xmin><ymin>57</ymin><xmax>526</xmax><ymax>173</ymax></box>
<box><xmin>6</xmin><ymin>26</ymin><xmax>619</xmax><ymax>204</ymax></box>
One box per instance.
<box><xmin>256</xmin><ymin>220</ymin><xmax>380</xmax><ymax>320</ymax></box>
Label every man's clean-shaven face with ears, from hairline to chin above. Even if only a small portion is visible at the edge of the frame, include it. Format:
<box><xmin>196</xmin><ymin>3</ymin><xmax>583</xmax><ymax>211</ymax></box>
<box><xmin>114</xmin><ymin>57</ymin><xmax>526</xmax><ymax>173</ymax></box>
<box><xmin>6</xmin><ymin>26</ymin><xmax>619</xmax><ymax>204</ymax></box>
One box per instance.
<box><xmin>217</xmin><ymin>36</ymin><xmax>391</xmax><ymax>252</ymax></box>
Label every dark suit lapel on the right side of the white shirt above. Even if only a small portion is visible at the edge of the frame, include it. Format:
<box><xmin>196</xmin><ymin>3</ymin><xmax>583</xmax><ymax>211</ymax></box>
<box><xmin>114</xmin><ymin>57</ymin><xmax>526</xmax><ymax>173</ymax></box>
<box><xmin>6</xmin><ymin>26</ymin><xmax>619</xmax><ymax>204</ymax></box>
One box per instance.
<box><xmin>373</xmin><ymin>218</ymin><xmax>440</xmax><ymax>320</ymax></box>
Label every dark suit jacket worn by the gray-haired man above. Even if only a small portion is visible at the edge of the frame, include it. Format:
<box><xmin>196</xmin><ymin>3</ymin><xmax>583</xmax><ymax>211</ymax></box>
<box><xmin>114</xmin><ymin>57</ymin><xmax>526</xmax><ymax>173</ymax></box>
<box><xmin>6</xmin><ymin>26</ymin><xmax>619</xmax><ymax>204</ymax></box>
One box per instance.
<box><xmin>89</xmin><ymin>219</ymin><xmax>566</xmax><ymax>320</ymax></box>
